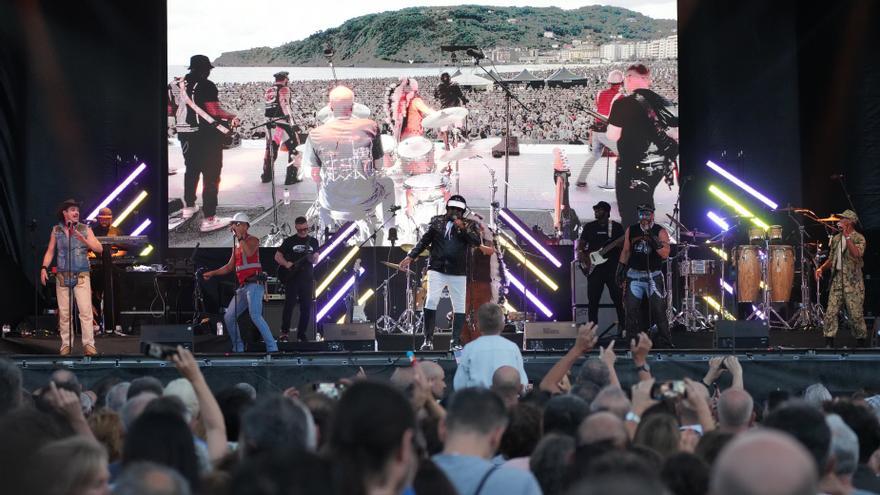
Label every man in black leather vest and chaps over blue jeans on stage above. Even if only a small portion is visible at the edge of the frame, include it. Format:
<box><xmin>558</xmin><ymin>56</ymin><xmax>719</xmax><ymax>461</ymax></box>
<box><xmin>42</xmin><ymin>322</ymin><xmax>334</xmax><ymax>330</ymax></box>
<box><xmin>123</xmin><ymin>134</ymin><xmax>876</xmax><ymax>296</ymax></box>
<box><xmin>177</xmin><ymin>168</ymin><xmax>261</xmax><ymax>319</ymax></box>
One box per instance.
<box><xmin>616</xmin><ymin>204</ymin><xmax>672</xmax><ymax>347</ymax></box>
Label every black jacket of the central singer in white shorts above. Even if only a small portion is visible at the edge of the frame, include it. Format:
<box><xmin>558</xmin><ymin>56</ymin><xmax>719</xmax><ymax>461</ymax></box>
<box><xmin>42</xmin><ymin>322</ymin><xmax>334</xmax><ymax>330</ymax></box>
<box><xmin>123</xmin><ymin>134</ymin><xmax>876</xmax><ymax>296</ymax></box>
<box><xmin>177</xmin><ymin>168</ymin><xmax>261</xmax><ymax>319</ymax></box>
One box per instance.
<box><xmin>407</xmin><ymin>215</ymin><xmax>481</xmax><ymax>275</ymax></box>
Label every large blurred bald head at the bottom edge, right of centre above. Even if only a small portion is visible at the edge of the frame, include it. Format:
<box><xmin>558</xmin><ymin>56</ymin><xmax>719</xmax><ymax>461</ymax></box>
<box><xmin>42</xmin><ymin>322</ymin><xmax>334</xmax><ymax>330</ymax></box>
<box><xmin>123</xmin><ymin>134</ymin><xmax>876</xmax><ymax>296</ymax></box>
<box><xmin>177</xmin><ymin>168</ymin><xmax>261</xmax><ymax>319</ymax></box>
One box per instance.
<box><xmin>709</xmin><ymin>429</ymin><xmax>818</xmax><ymax>495</ymax></box>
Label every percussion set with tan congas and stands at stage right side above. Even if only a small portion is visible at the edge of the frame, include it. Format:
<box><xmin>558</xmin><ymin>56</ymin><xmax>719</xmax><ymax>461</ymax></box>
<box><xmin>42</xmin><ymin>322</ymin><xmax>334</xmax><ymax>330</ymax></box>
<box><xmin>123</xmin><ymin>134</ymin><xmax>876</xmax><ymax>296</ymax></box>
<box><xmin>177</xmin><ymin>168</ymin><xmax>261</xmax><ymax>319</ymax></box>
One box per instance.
<box><xmin>667</xmin><ymin>207</ymin><xmax>838</xmax><ymax>331</ymax></box>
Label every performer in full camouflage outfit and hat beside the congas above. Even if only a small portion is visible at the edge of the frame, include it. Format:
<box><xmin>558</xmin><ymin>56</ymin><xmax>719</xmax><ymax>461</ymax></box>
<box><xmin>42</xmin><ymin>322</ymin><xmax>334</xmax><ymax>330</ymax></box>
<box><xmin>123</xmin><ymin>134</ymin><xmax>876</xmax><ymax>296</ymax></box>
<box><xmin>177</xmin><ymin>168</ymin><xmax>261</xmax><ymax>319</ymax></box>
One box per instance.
<box><xmin>816</xmin><ymin>210</ymin><xmax>868</xmax><ymax>347</ymax></box>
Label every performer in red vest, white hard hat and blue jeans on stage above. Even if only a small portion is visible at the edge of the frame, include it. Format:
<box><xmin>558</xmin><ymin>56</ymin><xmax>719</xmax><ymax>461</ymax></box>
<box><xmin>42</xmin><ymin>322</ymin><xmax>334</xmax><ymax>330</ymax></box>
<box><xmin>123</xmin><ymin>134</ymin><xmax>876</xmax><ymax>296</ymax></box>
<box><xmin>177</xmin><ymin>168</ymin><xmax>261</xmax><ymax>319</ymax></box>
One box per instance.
<box><xmin>202</xmin><ymin>213</ymin><xmax>278</xmax><ymax>352</ymax></box>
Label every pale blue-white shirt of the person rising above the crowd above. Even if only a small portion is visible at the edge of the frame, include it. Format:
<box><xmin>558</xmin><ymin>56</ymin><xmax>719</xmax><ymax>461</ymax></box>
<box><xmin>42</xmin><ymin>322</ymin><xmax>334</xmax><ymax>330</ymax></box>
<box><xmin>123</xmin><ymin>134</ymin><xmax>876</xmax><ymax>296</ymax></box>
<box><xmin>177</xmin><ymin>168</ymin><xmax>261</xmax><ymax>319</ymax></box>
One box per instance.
<box><xmin>452</xmin><ymin>335</ymin><xmax>529</xmax><ymax>390</ymax></box>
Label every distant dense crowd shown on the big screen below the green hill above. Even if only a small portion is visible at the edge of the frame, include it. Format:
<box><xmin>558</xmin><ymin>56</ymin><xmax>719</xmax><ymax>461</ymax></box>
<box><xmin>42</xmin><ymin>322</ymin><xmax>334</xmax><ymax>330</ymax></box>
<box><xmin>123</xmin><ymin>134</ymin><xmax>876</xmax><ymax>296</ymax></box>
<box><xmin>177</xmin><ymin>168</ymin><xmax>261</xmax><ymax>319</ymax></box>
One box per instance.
<box><xmin>170</xmin><ymin>60</ymin><xmax>678</xmax><ymax>144</ymax></box>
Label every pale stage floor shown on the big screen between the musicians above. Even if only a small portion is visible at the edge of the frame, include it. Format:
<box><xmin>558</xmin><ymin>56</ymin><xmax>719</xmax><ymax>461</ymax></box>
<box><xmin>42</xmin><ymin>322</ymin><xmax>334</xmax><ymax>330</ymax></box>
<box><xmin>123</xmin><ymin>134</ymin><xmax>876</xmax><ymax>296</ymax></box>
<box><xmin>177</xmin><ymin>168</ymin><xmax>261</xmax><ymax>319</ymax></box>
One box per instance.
<box><xmin>168</xmin><ymin>140</ymin><xmax>678</xmax><ymax>247</ymax></box>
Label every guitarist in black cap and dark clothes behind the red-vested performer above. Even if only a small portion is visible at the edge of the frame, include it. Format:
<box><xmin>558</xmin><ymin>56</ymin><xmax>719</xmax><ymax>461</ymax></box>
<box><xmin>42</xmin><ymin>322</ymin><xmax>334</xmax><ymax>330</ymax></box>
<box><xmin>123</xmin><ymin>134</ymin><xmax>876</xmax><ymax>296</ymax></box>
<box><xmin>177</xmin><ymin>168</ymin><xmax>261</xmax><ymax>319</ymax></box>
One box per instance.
<box><xmin>275</xmin><ymin>217</ymin><xmax>318</xmax><ymax>342</ymax></box>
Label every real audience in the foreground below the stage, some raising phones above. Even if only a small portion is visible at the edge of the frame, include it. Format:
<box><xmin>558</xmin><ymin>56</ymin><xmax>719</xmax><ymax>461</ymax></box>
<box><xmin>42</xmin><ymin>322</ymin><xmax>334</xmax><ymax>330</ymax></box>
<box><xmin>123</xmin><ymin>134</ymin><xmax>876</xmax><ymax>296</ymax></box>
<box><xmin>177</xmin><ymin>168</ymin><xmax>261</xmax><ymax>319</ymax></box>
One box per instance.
<box><xmin>0</xmin><ymin>314</ymin><xmax>880</xmax><ymax>495</ymax></box>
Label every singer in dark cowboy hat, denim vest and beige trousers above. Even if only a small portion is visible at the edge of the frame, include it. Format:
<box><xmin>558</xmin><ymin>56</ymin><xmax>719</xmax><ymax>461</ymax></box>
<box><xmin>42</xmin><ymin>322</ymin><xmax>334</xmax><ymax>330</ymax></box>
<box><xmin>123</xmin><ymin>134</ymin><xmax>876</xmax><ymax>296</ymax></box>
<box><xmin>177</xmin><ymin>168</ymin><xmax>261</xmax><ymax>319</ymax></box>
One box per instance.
<box><xmin>40</xmin><ymin>199</ymin><xmax>104</xmax><ymax>356</ymax></box>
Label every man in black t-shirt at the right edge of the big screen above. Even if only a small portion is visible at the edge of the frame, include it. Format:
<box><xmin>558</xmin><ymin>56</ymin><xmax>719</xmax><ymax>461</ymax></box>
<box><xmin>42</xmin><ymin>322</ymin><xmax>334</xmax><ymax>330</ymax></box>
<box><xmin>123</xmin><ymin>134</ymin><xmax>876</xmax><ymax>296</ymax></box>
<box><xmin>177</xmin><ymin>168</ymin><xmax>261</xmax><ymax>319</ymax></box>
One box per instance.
<box><xmin>605</xmin><ymin>64</ymin><xmax>678</xmax><ymax>225</ymax></box>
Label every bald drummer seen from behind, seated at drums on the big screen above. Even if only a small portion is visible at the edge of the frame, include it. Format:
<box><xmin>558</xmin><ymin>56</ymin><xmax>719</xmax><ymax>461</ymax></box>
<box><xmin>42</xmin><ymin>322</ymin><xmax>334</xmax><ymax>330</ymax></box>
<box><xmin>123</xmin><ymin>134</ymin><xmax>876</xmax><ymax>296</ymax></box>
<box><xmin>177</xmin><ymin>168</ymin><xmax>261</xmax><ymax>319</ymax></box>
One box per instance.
<box><xmin>302</xmin><ymin>86</ymin><xmax>394</xmax><ymax>244</ymax></box>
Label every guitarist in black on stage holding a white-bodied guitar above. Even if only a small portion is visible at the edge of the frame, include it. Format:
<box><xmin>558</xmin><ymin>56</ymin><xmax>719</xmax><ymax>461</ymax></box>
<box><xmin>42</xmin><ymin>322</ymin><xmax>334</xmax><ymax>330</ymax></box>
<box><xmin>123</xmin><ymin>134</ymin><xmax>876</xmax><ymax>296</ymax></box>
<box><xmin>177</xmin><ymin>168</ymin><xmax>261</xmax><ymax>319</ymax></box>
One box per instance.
<box><xmin>577</xmin><ymin>201</ymin><xmax>626</xmax><ymax>334</ymax></box>
